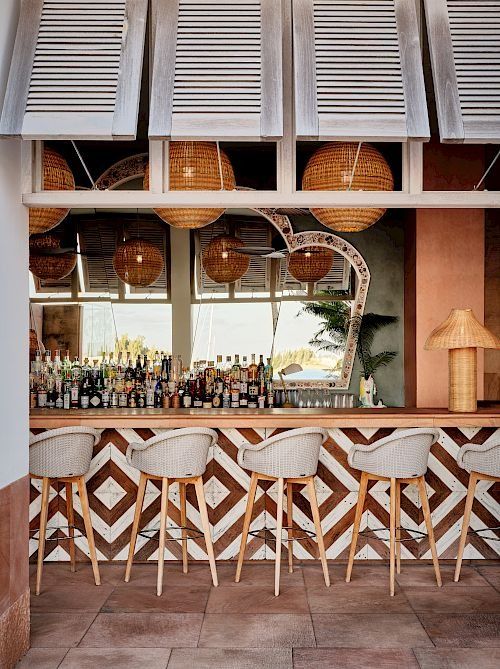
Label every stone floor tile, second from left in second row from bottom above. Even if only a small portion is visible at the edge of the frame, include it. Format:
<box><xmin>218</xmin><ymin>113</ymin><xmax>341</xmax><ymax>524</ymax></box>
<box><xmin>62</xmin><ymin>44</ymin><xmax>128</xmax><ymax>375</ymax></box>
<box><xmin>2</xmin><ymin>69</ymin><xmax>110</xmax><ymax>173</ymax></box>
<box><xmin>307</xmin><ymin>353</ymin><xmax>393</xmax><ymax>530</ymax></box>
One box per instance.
<box><xmin>80</xmin><ymin>613</ymin><xmax>203</xmax><ymax>648</ymax></box>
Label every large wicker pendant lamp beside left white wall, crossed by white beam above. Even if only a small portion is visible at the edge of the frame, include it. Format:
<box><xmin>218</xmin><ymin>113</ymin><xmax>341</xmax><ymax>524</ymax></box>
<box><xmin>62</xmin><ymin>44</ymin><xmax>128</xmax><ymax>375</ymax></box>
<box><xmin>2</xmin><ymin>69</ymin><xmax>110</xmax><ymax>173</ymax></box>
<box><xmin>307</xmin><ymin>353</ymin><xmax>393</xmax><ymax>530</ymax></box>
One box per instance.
<box><xmin>29</xmin><ymin>148</ymin><xmax>75</xmax><ymax>235</ymax></box>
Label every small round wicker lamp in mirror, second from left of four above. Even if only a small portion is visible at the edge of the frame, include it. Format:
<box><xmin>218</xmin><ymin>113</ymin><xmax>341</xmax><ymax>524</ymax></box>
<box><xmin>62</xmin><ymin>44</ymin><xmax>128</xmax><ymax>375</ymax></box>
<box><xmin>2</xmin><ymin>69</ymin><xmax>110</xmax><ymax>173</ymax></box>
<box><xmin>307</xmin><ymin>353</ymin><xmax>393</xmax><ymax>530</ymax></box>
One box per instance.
<box><xmin>113</xmin><ymin>238</ymin><xmax>164</xmax><ymax>288</ymax></box>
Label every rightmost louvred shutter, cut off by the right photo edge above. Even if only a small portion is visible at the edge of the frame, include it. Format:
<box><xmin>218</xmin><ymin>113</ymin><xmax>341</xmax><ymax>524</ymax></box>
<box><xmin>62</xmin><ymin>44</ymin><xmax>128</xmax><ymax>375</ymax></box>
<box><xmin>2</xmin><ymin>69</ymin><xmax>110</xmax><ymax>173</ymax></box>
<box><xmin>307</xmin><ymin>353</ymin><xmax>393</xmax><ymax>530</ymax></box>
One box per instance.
<box><xmin>425</xmin><ymin>0</ymin><xmax>500</xmax><ymax>143</ymax></box>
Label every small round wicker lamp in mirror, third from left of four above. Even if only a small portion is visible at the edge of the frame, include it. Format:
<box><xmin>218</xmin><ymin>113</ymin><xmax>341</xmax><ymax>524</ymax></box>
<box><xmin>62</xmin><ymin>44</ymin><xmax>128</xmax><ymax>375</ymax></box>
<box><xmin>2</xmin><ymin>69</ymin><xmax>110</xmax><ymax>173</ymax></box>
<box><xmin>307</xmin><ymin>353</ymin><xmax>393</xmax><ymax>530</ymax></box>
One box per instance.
<box><xmin>202</xmin><ymin>235</ymin><xmax>250</xmax><ymax>283</ymax></box>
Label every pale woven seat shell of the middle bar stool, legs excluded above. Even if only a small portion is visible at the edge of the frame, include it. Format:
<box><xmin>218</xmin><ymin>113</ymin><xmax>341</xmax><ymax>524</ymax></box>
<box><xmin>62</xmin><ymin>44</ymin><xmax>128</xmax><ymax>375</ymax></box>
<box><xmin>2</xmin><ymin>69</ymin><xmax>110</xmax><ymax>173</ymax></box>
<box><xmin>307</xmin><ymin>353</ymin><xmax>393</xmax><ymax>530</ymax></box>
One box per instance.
<box><xmin>238</xmin><ymin>427</ymin><xmax>328</xmax><ymax>479</ymax></box>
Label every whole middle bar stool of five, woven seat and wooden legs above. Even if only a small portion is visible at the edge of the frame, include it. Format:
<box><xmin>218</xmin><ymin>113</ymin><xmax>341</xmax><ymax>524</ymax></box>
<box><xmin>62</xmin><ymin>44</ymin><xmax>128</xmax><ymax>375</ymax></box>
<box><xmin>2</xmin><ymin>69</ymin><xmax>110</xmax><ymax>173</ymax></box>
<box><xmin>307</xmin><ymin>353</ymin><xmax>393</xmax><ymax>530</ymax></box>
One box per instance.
<box><xmin>235</xmin><ymin>427</ymin><xmax>330</xmax><ymax>597</ymax></box>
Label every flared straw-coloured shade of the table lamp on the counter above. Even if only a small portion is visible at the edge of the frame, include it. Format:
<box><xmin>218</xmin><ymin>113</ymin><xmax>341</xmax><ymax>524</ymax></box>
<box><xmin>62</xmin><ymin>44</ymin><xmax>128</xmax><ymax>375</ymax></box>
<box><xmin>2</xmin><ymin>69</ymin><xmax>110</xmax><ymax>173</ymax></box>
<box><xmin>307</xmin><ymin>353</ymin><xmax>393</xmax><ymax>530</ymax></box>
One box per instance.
<box><xmin>425</xmin><ymin>309</ymin><xmax>500</xmax><ymax>351</ymax></box>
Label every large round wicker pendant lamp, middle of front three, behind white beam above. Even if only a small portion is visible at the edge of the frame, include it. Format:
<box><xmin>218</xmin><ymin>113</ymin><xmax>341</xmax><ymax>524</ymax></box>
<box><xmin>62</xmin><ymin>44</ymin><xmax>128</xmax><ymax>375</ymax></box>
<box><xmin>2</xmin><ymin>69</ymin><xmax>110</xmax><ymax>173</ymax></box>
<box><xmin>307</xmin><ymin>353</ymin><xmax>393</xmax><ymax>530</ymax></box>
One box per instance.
<box><xmin>144</xmin><ymin>142</ymin><xmax>236</xmax><ymax>229</ymax></box>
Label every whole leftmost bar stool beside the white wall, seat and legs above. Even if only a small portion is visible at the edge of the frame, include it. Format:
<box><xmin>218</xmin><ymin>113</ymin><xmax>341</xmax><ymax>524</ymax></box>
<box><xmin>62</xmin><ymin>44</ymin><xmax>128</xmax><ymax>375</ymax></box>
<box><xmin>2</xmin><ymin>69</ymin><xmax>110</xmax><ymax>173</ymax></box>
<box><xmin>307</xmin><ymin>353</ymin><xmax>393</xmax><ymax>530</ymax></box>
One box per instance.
<box><xmin>29</xmin><ymin>427</ymin><xmax>101</xmax><ymax>595</ymax></box>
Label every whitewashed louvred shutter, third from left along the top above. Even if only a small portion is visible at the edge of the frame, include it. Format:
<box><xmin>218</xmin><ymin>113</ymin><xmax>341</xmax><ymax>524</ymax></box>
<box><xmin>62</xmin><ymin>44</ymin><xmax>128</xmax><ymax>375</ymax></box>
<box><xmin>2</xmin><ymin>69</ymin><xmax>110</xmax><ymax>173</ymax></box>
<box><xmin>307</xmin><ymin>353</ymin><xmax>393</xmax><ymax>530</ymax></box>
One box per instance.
<box><xmin>293</xmin><ymin>0</ymin><xmax>430</xmax><ymax>142</ymax></box>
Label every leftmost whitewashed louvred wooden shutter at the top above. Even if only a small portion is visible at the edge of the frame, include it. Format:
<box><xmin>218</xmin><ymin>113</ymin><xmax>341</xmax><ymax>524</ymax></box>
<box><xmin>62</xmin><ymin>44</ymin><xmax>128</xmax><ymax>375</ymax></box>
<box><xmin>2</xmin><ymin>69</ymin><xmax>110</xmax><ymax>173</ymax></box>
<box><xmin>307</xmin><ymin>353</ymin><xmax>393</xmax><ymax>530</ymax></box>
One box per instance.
<box><xmin>0</xmin><ymin>0</ymin><xmax>148</xmax><ymax>139</ymax></box>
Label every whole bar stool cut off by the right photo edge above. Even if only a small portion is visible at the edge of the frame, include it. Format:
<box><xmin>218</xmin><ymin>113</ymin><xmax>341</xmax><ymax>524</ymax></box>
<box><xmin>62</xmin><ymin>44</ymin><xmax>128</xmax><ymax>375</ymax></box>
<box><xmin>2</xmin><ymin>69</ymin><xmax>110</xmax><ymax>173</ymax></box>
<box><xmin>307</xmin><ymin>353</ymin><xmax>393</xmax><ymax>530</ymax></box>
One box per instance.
<box><xmin>454</xmin><ymin>441</ymin><xmax>500</xmax><ymax>581</ymax></box>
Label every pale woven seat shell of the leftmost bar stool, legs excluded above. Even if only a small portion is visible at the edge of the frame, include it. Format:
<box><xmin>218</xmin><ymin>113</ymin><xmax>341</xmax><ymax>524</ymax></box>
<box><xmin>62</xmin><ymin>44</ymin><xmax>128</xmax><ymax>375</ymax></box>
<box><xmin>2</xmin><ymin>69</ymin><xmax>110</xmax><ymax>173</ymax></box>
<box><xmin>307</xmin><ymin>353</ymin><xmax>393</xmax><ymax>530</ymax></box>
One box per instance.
<box><xmin>30</xmin><ymin>427</ymin><xmax>101</xmax><ymax>478</ymax></box>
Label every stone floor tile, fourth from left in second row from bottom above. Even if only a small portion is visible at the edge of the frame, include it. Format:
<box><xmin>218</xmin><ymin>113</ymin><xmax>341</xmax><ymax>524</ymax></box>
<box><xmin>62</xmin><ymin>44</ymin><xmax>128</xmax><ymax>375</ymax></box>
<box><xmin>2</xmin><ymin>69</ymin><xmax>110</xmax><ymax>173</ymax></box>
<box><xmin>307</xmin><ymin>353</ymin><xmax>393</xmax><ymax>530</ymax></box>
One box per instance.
<box><xmin>312</xmin><ymin>613</ymin><xmax>432</xmax><ymax>649</ymax></box>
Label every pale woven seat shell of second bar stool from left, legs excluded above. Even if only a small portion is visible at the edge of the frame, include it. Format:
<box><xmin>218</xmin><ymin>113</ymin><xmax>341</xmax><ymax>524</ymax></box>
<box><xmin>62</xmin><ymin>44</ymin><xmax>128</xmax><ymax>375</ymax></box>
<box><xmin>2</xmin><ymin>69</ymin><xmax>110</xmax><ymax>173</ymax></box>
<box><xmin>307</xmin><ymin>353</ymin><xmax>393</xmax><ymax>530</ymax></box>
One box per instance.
<box><xmin>127</xmin><ymin>427</ymin><xmax>217</xmax><ymax>479</ymax></box>
